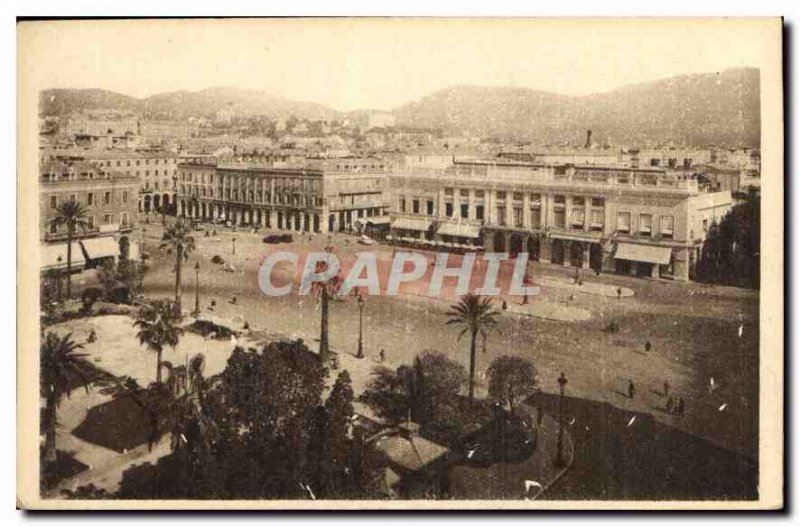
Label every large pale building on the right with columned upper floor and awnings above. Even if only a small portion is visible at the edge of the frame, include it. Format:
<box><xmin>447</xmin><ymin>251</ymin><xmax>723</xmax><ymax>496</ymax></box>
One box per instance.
<box><xmin>390</xmin><ymin>161</ymin><xmax>732</xmax><ymax>280</ymax></box>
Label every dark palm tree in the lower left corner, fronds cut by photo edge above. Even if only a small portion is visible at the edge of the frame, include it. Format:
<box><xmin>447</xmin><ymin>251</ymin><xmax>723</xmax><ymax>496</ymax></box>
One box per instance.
<box><xmin>39</xmin><ymin>332</ymin><xmax>89</xmax><ymax>463</ymax></box>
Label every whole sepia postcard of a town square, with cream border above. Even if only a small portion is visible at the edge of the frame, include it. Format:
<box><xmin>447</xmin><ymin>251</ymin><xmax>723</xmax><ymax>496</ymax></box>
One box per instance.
<box><xmin>17</xmin><ymin>18</ymin><xmax>784</xmax><ymax>510</ymax></box>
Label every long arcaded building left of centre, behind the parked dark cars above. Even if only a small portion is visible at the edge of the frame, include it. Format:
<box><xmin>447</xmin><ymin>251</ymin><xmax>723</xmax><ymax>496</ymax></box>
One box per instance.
<box><xmin>177</xmin><ymin>158</ymin><xmax>390</xmax><ymax>233</ymax></box>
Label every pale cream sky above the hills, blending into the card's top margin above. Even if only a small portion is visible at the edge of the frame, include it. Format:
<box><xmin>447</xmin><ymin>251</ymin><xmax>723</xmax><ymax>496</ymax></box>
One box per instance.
<box><xmin>20</xmin><ymin>19</ymin><xmax>780</xmax><ymax>110</ymax></box>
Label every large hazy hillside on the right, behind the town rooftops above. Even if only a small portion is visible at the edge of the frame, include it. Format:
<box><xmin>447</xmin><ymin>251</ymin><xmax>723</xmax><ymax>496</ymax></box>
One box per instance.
<box><xmin>394</xmin><ymin>69</ymin><xmax>760</xmax><ymax>146</ymax></box>
